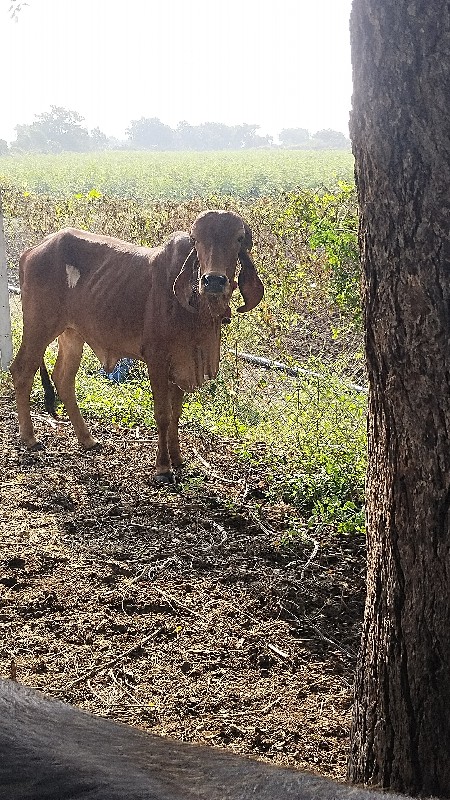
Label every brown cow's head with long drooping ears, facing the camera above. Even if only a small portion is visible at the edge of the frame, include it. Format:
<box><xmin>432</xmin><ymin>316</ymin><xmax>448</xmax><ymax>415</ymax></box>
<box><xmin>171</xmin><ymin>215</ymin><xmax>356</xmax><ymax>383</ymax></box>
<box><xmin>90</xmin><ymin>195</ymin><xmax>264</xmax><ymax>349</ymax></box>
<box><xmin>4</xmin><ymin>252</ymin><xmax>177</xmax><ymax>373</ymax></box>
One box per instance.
<box><xmin>174</xmin><ymin>211</ymin><xmax>264</xmax><ymax>317</ymax></box>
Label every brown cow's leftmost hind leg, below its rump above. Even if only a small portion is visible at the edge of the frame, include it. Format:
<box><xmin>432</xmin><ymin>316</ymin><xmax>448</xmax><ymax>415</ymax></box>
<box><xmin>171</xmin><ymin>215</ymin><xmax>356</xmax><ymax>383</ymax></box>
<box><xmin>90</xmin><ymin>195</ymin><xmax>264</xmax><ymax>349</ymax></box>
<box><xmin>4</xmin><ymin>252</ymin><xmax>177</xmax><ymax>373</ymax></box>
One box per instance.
<box><xmin>10</xmin><ymin>336</ymin><xmax>48</xmax><ymax>450</ymax></box>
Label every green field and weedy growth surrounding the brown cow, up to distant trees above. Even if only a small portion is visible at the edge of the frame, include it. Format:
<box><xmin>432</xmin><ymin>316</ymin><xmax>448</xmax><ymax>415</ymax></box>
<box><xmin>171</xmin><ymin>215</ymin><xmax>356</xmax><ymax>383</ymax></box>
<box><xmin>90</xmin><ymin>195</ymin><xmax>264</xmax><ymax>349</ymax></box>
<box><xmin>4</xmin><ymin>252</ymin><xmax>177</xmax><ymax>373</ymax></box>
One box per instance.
<box><xmin>0</xmin><ymin>150</ymin><xmax>366</xmax><ymax>532</ymax></box>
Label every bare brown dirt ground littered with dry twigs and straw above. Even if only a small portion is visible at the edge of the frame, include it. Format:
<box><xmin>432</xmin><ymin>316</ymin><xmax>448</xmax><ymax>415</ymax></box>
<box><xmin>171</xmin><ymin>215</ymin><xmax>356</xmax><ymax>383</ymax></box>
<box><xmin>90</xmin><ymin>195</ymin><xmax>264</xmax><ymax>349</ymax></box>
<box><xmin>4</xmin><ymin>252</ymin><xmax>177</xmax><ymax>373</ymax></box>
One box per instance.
<box><xmin>0</xmin><ymin>393</ymin><xmax>365</xmax><ymax>779</ymax></box>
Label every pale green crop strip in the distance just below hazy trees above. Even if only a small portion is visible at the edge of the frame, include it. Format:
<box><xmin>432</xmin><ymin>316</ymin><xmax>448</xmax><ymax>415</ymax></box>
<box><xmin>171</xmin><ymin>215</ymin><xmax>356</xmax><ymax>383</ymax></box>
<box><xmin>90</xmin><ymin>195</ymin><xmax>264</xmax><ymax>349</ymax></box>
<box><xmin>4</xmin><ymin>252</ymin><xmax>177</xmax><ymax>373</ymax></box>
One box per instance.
<box><xmin>0</xmin><ymin>150</ymin><xmax>353</xmax><ymax>201</ymax></box>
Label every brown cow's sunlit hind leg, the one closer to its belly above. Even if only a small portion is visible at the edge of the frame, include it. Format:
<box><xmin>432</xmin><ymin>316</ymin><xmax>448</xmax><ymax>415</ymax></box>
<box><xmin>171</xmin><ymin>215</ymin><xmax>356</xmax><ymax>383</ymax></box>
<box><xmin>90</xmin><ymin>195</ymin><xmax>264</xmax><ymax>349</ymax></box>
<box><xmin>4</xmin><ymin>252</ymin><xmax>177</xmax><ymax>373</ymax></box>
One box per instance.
<box><xmin>52</xmin><ymin>328</ymin><xmax>99</xmax><ymax>450</ymax></box>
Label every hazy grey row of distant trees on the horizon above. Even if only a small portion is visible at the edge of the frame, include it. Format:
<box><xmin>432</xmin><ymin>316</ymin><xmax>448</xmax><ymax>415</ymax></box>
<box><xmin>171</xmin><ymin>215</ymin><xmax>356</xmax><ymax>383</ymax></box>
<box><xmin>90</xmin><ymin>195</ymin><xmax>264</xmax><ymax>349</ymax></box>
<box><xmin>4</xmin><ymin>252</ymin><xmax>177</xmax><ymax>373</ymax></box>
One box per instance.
<box><xmin>0</xmin><ymin>106</ymin><xmax>350</xmax><ymax>155</ymax></box>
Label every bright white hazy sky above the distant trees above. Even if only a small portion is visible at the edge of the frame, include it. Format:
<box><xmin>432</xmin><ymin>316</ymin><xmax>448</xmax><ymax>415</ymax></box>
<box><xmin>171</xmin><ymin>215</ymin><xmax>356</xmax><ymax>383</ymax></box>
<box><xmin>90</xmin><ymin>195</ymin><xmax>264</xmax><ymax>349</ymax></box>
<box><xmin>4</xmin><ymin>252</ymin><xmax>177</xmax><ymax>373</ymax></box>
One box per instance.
<box><xmin>0</xmin><ymin>0</ymin><xmax>352</xmax><ymax>141</ymax></box>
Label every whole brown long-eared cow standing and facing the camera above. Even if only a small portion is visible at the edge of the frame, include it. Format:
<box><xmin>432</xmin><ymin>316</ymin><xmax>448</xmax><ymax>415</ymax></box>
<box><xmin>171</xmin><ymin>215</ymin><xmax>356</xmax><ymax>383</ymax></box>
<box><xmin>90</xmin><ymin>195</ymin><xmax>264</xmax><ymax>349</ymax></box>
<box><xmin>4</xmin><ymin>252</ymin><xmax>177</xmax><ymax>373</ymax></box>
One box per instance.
<box><xmin>11</xmin><ymin>211</ymin><xmax>264</xmax><ymax>483</ymax></box>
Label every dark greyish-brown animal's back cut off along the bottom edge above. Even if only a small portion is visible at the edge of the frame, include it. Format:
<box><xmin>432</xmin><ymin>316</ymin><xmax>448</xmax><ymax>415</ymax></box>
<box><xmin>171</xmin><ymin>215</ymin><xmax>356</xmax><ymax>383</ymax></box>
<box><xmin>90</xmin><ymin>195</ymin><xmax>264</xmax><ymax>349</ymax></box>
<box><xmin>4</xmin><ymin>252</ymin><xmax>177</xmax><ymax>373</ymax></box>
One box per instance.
<box><xmin>0</xmin><ymin>681</ymin><xmax>414</xmax><ymax>800</ymax></box>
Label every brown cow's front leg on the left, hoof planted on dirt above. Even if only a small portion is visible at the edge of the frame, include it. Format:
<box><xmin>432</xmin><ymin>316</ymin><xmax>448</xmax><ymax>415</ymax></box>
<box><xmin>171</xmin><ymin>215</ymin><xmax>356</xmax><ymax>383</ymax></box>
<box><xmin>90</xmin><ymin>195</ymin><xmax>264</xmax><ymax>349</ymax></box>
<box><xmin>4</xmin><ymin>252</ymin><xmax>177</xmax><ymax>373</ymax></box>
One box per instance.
<box><xmin>148</xmin><ymin>364</ymin><xmax>175</xmax><ymax>484</ymax></box>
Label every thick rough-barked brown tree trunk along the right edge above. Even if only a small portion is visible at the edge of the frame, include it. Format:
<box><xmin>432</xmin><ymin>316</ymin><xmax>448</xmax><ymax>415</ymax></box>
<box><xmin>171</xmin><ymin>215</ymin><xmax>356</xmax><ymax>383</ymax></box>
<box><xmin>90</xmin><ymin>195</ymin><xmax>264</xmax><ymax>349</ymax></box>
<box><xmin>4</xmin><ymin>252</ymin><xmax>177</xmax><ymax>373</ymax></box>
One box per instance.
<box><xmin>348</xmin><ymin>0</ymin><xmax>450</xmax><ymax>797</ymax></box>
